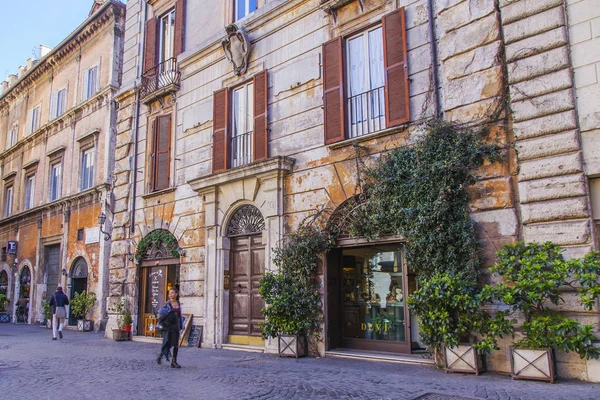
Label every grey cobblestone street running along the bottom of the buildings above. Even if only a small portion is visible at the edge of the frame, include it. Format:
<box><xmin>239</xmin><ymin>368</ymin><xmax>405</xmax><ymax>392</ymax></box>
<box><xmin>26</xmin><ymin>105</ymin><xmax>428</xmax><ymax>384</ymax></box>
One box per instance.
<box><xmin>0</xmin><ymin>324</ymin><xmax>600</xmax><ymax>400</ymax></box>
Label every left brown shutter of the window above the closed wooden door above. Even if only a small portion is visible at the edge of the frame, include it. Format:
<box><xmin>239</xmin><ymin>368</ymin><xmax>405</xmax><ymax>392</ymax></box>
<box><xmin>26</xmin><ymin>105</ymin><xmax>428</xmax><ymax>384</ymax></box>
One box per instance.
<box><xmin>213</xmin><ymin>88</ymin><xmax>231</xmax><ymax>173</ymax></box>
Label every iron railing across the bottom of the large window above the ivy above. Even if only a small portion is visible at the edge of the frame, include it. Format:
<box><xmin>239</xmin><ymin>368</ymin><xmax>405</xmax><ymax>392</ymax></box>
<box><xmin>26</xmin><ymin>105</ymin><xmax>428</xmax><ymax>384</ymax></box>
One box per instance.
<box><xmin>348</xmin><ymin>86</ymin><xmax>386</xmax><ymax>139</ymax></box>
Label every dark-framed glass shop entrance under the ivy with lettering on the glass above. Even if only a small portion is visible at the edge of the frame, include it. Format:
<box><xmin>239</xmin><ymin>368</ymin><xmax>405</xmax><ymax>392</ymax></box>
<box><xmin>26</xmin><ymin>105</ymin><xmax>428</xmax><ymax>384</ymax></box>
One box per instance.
<box><xmin>327</xmin><ymin>244</ymin><xmax>414</xmax><ymax>353</ymax></box>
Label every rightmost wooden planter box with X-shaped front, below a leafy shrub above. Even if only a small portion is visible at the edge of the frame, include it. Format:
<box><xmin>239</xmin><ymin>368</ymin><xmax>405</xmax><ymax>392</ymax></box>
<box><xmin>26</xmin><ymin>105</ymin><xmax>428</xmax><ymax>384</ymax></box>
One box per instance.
<box><xmin>510</xmin><ymin>346</ymin><xmax>556</xmax><ymax>383</ymax></box>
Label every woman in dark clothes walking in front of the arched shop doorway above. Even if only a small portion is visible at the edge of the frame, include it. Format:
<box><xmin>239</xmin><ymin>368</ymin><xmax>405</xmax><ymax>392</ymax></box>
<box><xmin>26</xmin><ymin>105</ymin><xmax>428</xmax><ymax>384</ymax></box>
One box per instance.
<box><xmin>156</xmin><ymin>289</ymin><xmax>183</xmax><ymax>368</ymax></box>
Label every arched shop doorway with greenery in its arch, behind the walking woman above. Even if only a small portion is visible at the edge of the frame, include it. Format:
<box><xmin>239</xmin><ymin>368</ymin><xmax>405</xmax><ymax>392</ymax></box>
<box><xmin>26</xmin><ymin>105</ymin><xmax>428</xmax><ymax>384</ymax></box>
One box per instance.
<box><xmin>137</xmin><ymin>229</ymin><xmax>182</xmax><ymax>336</ymax></box>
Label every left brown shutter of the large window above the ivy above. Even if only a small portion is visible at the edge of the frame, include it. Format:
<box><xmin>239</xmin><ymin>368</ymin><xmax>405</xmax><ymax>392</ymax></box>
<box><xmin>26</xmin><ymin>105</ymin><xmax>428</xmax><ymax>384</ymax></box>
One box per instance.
<box><xmin>323</xmin><ymin>38</ymin><xmax>345</xmax><ymax>144</ymax></box>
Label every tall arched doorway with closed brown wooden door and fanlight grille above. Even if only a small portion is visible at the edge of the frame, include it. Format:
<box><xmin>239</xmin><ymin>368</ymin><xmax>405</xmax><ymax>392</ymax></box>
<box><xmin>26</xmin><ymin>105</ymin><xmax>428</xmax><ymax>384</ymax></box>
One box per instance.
<box><xmin>227</xmin><ymin>205</ymin><xmax>265</xmax><ymax>343</ymax></box>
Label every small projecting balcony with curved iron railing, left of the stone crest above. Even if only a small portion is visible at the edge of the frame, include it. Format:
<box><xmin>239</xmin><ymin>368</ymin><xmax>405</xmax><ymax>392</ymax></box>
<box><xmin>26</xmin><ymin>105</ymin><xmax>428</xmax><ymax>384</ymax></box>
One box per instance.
<box><xmin>140</xmin><ymin>58</ymin><xmax>181</xmax><ymax>103</ymax></box>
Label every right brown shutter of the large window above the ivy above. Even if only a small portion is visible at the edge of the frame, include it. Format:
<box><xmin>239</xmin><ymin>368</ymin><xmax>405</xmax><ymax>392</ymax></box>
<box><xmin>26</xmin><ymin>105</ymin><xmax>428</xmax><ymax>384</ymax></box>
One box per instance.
<box><xmin>383</xmin><ymin>8</ymin><xmax>410</xmax><ymax>127</ymax></box>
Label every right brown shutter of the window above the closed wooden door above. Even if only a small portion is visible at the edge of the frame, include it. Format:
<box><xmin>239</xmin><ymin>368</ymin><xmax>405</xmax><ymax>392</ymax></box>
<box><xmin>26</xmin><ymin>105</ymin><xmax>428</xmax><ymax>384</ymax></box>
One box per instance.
<box><xmin>252</xmin><ymin>70</ymin><xmax>269</xmax><ymax>161</ymax></box>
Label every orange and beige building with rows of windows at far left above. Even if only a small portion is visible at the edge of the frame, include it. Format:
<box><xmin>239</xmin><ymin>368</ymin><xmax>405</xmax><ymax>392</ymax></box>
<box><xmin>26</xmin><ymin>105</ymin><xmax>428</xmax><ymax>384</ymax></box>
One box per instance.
<box><xmin>0</xmin><ymin>0</ymin><xmax>125</xmax><ymax>329</ymax></box>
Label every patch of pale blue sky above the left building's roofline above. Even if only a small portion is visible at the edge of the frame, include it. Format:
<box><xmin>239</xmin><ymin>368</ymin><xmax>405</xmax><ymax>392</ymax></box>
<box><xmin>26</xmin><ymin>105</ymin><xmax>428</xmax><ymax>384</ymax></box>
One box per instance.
<box><xmin>0</xmin><ymin>0</ymin><xmax>125</xmax><ymax>81</ymax></box>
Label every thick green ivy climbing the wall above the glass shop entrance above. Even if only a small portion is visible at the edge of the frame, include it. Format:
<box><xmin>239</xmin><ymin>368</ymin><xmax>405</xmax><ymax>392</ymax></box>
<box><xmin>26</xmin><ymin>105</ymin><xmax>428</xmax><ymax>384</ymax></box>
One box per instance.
<box><xmin>350</xmin><ymin>121</ymin><xmax>501</xmax><ymax>279</ymax></box>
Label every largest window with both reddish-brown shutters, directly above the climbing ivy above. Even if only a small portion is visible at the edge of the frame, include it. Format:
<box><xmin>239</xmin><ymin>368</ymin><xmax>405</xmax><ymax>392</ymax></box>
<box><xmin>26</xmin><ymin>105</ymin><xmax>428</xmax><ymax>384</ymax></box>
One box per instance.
<box><xmin>323</xmin><ymin>8</ymin><xmax>410</xmax><ymax>144</ymax></box>
